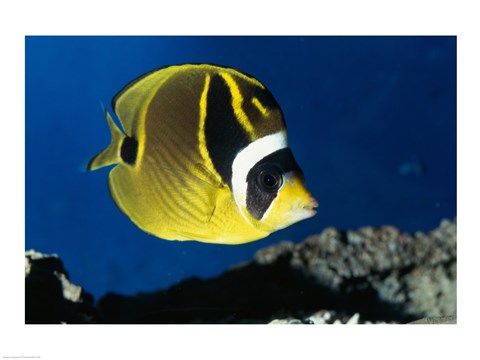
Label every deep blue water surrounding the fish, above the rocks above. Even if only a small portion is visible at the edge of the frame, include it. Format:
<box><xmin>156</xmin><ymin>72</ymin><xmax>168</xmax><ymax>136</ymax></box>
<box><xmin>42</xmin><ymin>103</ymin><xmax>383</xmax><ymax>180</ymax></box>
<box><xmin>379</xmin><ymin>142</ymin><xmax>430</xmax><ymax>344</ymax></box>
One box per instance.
<box><xmin>25</xmin><ymin>37</ymin><xmax>456</xmax><ymax>299</ymax></box>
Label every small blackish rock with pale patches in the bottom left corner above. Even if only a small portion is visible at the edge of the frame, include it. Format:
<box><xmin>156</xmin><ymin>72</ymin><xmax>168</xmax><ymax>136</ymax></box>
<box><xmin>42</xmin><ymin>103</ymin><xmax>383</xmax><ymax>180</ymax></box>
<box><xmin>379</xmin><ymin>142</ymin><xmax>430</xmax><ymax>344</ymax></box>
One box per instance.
<box><xmin>25</xmin><ymin>250</ymin><xmax>98</xmax><ymax>324</ymax></box>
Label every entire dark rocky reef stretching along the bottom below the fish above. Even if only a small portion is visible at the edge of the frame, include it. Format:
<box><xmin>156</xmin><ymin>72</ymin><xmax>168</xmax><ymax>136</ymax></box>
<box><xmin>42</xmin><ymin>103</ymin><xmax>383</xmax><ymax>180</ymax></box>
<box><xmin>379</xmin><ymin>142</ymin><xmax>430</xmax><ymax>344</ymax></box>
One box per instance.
<box><xmin>25</xmin><ymin>220</ymin><xmax>457</xmax><ymax>324</ymax></box>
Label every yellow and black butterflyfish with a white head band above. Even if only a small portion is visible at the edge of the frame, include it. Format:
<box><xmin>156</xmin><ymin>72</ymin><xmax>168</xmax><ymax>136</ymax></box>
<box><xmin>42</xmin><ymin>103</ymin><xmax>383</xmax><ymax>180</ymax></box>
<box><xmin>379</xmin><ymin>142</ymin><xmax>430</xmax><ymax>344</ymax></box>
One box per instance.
<box><xmin>88</xmin><ymin>64</ymin><xmax>317</xmax><ymax>244</ymax></box>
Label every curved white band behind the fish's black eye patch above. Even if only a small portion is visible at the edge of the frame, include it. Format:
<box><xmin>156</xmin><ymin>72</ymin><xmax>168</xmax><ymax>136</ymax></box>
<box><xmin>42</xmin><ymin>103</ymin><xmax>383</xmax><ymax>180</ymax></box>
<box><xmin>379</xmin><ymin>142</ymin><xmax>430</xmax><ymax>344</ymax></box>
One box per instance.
<box><xmin>232</xmin><ymin>131</ymin><xmax>288</xmax><ymax>221</ymax></box>
